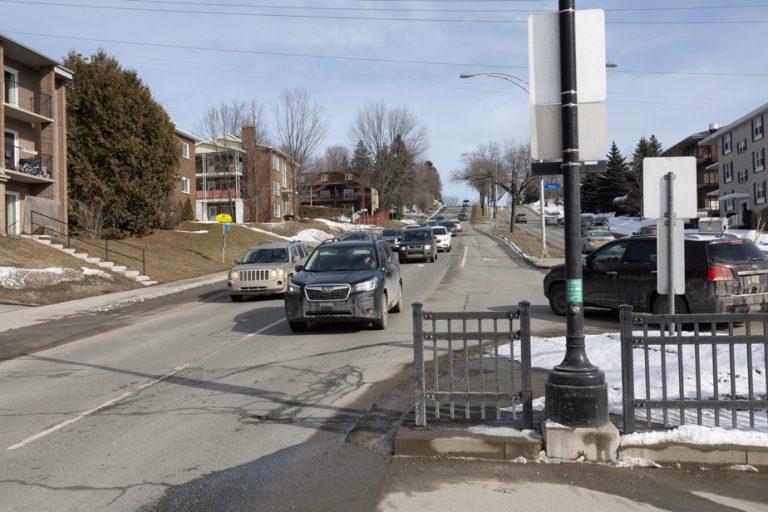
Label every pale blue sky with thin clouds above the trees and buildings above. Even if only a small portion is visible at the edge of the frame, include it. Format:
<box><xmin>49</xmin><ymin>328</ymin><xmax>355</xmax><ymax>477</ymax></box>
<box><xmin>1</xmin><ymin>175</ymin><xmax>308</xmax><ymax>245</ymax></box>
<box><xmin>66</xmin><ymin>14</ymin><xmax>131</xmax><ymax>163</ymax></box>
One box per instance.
<box><xmin>0</xmin><ymin>0</ymin><xmax>768</xmax><ymax>199</ymax></box>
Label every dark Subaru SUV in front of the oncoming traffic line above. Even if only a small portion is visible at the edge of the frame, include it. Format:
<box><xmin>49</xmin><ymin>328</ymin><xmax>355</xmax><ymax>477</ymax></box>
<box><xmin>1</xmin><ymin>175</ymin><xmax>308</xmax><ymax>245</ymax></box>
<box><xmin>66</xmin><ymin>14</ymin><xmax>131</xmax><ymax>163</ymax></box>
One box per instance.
<box><xmin>285</xmin><ymin>240</ymin><xmax>403</xmax><ymax>332</ymax></box>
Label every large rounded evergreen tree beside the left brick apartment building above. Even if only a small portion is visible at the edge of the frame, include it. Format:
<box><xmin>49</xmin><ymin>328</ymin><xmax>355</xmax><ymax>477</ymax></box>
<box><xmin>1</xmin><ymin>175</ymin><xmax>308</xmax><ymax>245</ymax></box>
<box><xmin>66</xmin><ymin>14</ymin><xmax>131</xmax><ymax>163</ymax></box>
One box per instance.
<box><xmin>64</xmin><ymin>50</ymin><xmax>180</xmax><ymax>236</ymax></box>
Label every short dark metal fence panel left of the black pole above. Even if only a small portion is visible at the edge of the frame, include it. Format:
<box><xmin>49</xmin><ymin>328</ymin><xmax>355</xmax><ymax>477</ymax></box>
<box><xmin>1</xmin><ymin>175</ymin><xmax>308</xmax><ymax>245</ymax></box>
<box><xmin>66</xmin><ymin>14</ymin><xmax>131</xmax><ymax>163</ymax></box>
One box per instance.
<box><xmin>413</xmin><ymin>302</ymin><xmax>533</xmax><ymax>428</ymax></box>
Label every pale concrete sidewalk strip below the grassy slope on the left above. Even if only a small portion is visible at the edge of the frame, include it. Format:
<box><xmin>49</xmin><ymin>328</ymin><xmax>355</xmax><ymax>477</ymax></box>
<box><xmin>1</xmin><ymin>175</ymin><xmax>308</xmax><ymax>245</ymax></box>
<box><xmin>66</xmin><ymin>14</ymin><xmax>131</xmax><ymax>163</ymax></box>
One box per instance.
<box><xmin>0</xmin><ymin>272</ymin><xmax>227</xmax><ymax>332</ymax></box>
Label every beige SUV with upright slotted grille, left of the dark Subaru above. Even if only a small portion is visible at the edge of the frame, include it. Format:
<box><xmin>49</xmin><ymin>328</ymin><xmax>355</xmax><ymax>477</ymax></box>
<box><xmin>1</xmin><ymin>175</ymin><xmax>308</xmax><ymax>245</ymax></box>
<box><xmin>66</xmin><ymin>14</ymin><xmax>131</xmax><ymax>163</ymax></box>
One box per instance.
<box><xmin>227</xmin><ymin>241</ymin><xmax>309</xmax><ymax>302</ymax></box>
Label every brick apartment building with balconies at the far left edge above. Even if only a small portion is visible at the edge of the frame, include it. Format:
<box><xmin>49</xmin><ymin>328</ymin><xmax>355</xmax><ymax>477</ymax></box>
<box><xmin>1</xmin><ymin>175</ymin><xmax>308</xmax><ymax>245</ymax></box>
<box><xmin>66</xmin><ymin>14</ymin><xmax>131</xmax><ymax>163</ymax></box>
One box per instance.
<box><xmin>0</xmin><ymin>34</ymin><xmax>73</xmax><ymax>234</ymax></box>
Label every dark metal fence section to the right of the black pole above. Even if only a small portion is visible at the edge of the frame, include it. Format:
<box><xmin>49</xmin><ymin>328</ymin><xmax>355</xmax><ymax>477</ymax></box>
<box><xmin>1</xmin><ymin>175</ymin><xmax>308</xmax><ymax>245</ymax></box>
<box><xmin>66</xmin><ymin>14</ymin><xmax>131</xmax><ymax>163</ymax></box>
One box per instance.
<box><xmin>621</xmin><ymin>306</ymin><xmax>768</xmax><ymax>434</ymax></box>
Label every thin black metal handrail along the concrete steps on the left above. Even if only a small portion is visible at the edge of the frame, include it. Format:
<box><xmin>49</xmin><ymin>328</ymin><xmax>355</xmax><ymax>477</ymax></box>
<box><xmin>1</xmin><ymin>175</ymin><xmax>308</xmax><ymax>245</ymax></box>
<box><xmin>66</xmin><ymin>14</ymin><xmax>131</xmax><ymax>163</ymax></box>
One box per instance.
<box><xmin>30</xmin><ymin>210</ymin><xmax>147</xmax><ymax>275</ymax></box>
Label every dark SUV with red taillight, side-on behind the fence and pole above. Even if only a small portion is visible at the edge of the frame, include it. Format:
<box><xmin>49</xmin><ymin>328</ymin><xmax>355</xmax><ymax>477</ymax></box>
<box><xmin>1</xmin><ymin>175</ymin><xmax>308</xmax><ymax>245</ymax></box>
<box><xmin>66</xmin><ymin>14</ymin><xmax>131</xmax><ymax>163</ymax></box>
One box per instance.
<box><xmin>543</xmin><ymin>235</ymin><xmax>768</xmax><ymax>315</ymax></box>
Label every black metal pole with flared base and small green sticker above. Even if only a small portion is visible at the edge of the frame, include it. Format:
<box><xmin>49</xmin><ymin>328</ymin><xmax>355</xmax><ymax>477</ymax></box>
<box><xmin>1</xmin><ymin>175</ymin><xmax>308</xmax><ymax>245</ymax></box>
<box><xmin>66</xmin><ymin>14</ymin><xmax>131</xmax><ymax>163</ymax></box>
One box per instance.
<box><xmin>545</xmin><ymin>0</ymin><xmax>608</xmax><ymax>427</ymax></box>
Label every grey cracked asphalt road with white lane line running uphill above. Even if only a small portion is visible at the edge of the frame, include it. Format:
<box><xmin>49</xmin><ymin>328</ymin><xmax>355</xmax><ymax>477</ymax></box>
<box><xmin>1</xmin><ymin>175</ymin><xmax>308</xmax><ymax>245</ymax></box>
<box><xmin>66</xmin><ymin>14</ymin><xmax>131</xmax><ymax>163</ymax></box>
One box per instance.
<box><xmin>0</xmin><ymin>225</ymin><xmax>766</xmax><ymax>512</ymax></box>
